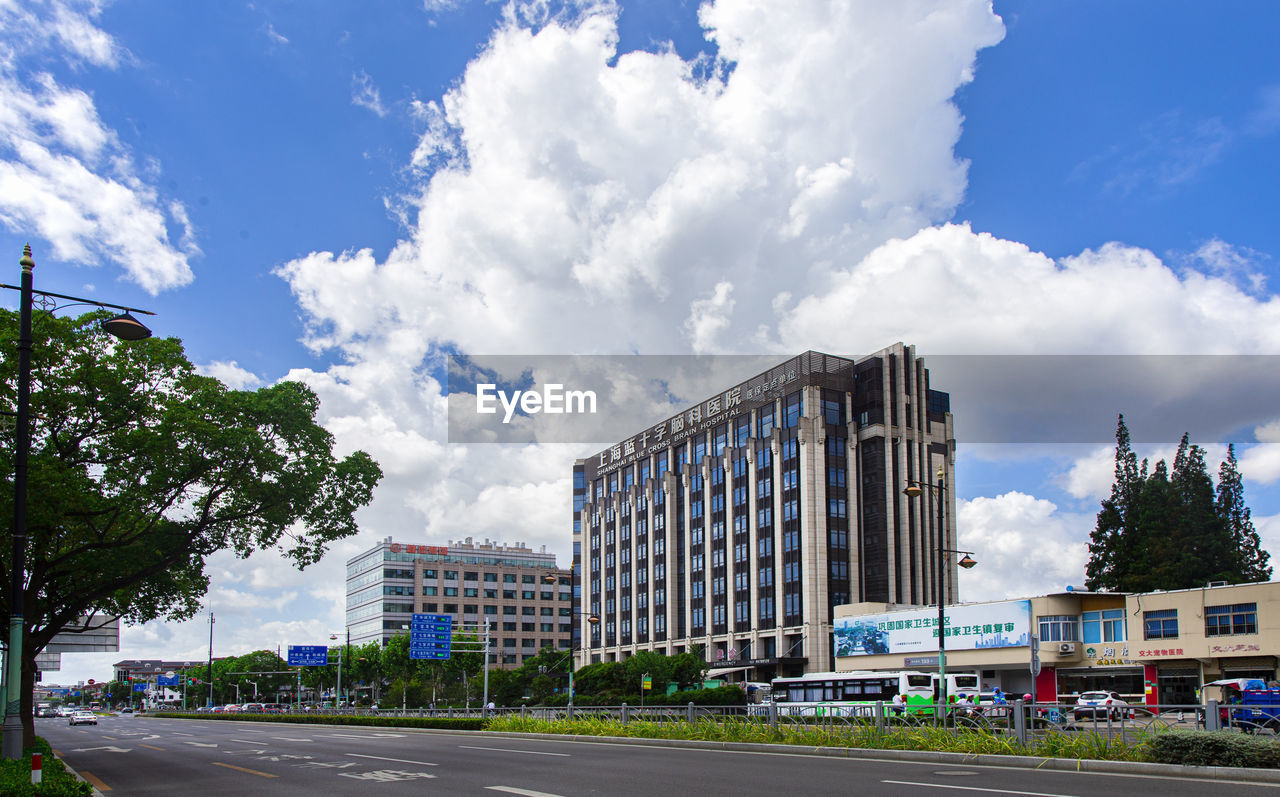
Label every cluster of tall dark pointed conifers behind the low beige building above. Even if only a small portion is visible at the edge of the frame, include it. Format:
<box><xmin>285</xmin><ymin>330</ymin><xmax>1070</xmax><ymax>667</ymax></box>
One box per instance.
<box><xmin>1085</xmin><ymin>416</ymin><xmax>1271</xmax><ymax>592</ymax></box>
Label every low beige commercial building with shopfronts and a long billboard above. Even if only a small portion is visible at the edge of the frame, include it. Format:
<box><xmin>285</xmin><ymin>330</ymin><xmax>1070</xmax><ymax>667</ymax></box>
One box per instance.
<box><xmin>833</xmin><ymin>582</ymin><xmax>1280</xmax><ymax>705</ymax></box>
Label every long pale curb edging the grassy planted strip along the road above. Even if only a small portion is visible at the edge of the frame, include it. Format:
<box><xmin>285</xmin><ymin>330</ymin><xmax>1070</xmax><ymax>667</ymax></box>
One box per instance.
<box><xmin>149</xmin><ymin>718</ymin><xmax>1280</xmax><ymax>797</ymax></box>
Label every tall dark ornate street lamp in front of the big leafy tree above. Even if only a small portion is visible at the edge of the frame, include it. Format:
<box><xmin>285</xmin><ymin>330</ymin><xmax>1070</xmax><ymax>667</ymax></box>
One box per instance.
<box><xmin>0</xmin><ymin>243</ymin><xmax>155</xmax><ymax>760</ymax></box>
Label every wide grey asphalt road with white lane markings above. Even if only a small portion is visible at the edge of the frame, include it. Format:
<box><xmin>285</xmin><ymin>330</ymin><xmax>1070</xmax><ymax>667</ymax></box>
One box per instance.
<box><xmin>36</xmin><ymin>716</ymin><xmax>1280</xmax><ymax>797</ymax></box>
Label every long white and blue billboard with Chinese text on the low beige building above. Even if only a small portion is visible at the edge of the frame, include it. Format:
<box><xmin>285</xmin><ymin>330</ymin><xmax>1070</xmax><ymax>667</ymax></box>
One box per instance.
<box><xmin>832</xmin><ymin>600</ymin><xmax>1032</xmax><ymax>656</ymax></box>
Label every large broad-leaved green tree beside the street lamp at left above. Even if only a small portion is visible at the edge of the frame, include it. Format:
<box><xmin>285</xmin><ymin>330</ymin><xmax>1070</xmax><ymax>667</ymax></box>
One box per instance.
<box><xmin>0</xmin><ymin>312</ymin><xmax>381</xmax><ymax>743</ymax></box>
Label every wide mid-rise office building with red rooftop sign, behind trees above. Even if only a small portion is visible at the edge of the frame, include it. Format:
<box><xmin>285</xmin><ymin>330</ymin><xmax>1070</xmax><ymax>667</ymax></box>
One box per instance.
<box><xmin>347</xmin><ymin>537</ymin><xmax>573</xmax><ymax>668</ymax></box>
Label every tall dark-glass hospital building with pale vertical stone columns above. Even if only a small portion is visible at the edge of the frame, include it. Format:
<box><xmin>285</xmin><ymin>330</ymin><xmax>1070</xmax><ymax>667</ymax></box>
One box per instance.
<box><xmin>573</xmin><ymin>344</ymin><xmax>956</xmax><ymax>681</ymax></box>
